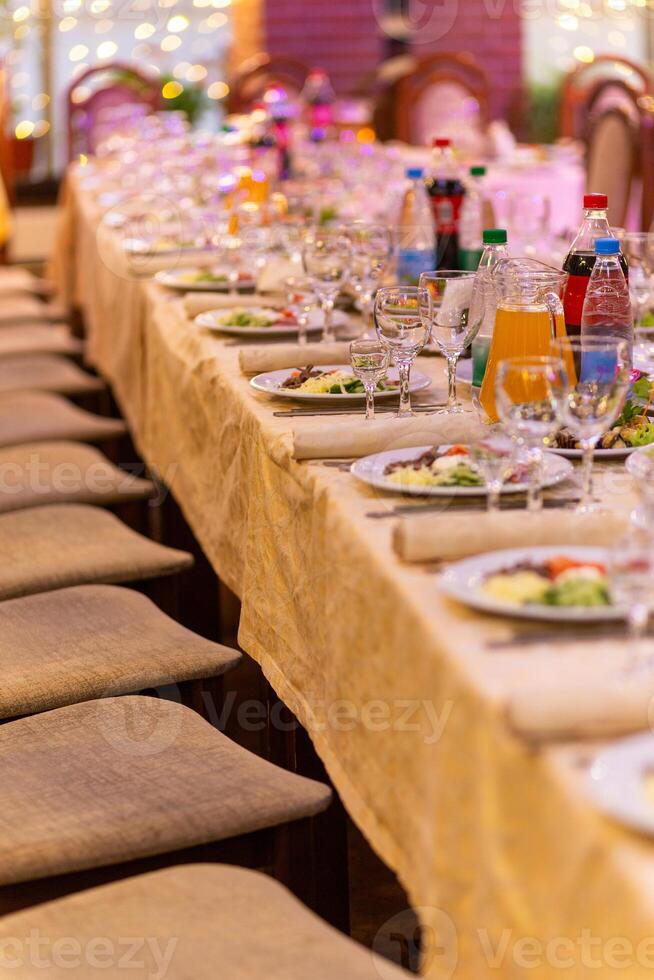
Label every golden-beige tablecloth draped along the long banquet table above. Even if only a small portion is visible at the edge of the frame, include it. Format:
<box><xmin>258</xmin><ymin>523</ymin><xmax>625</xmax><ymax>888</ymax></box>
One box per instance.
<box><xmin>54</xmin><ymin>169</ymin><xmax>654</xmax><ymax>980</ymax></box>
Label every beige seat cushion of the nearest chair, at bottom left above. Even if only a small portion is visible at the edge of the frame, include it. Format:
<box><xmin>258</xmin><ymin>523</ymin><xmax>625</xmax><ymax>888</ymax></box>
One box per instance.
<box><xmin>0</xmin><ymin>864</ymin><xmax>414</xmax><ymax>980</ymax></box>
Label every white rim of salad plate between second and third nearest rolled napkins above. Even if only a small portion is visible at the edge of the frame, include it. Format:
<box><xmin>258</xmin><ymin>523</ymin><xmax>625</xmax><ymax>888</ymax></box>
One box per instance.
<box><xmin>351</xmin><ymin>446</ymin><xmax>574</xmax><ymax>497</ymax></box>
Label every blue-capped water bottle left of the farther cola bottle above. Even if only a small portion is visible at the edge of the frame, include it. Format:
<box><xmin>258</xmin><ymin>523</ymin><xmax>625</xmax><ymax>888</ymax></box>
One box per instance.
<box><xmin>397</xmin><ymin>167</ymin><xmax>436</xmax><ymax>286</ymax></box>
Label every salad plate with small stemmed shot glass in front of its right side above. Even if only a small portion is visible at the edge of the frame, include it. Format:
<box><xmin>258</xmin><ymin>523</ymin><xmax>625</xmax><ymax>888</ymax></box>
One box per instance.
<box><xmin>250</xmin><ymin>364</ymin><xmax>431</xmax><ymax>402</ymax></box>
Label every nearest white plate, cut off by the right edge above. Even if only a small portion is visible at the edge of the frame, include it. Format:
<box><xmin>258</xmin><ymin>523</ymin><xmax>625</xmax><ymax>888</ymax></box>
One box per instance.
<box><xmin>588</xmin><ymin>733</ymin><xmax>654</xmax><ymax>834</ymax></box>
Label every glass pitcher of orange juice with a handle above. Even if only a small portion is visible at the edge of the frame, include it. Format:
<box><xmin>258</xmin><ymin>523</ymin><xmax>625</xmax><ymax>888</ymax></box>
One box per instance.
<box><xmin>479</xmin><ymin>259</ymin><xmax>567</xmax><ymax>422</ymax></box>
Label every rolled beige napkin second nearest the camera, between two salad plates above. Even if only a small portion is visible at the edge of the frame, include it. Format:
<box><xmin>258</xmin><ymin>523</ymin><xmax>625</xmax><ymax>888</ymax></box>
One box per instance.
<box><xmin>393</xmin><ymin>510</ymin><xmax>629</xmax><ymax>561</ymax></box>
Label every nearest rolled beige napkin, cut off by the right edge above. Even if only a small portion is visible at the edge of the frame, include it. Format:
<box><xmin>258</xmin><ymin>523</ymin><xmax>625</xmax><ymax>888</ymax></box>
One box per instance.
<box><xmin>506</xmin><ymin>672</ymin><xmax>652</xmax><ymax>741</ymax></box>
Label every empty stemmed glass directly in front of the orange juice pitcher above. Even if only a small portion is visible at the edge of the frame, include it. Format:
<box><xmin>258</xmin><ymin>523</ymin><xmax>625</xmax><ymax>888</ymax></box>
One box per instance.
<box><xmin>495</xmin><ymin>357</ymin><xmax>567</xmax><ymax>511</ymax></box>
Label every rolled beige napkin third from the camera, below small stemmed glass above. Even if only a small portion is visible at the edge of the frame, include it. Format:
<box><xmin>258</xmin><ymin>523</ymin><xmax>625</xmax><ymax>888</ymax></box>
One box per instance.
<box><xmin>293</xmin><ymin>413</ymin><xmax>483</xmax><ymax>459</ymax></box>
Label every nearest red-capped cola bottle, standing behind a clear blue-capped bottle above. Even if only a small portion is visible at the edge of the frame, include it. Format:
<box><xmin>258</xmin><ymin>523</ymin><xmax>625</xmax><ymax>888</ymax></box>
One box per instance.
<box><xmin>563</xmin><ymin>194</ymin><xmax>627</xmax><ymax>337</ymax></box>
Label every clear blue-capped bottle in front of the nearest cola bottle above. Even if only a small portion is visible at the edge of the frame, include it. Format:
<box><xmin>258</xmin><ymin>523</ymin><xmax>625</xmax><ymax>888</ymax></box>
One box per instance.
<box><xmin>581</xmin><ymin>238</ymin><xmax>634</xmax><ymax>362</ymax></box>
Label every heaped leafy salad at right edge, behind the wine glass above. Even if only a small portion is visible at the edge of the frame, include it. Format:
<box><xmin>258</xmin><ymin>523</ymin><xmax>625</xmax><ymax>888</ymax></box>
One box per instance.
<box><xmin>551</xmin><ymin>371</ymin><xmax>654</xmax><ymax>459</ymax></box>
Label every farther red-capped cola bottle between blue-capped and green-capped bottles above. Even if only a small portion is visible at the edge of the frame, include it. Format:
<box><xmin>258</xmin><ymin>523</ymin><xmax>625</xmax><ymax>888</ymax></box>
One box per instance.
<box><xmin>426</xmin><ymin>139</ymin><xmax>465</xmax><ymax>269</ymax></box>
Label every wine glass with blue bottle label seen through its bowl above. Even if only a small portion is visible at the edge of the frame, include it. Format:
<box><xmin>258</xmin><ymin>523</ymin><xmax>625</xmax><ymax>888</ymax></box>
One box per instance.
<box><xmin>551</xmin><ymin>336</ymin><xmax>630</xmax><ymax>513</ymax></box>
